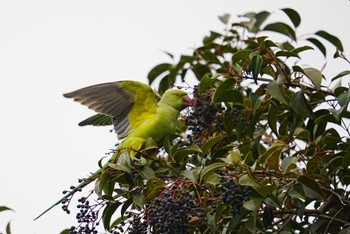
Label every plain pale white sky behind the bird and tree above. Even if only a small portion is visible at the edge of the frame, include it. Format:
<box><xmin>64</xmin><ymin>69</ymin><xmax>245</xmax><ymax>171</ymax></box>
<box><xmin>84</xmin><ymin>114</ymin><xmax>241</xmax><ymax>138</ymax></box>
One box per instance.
<box><xmin>0</xmin><ymin>0</ymin><xmax>350</xmax><ymax>234</ymax></box>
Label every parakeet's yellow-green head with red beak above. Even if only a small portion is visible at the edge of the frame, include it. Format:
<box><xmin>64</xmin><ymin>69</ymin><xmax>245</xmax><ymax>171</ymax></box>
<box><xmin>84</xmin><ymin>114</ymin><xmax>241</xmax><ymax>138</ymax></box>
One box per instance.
<box><xmin>159</xmin><ymin>89</ymin><xmax>193</xmax><ymax>110</ymax></box>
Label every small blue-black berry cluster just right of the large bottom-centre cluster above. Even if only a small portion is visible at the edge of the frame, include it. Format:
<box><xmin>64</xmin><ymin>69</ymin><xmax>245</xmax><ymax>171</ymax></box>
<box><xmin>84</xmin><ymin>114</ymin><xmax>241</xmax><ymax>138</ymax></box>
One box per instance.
<box><xmin>220</xmin><ymin>177</ymin><xmax>249</xmax><ymax>215</ymax></box>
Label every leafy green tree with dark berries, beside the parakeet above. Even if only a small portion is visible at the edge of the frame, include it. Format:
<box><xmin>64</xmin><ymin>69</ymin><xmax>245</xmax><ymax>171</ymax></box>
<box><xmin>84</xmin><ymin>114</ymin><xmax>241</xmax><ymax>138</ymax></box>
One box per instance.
<box><xmin>64</xmin><ymin>8</ymin><xmax>350</xmax><ymax>233</ymax></box>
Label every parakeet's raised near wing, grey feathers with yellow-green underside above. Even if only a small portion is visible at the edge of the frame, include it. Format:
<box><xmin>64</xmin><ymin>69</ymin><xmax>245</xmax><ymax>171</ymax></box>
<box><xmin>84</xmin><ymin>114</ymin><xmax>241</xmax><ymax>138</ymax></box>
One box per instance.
<box><xmin>63</xmin><ymin>81</ymin><xmax>157</xmax><ymax>139</ymax></box>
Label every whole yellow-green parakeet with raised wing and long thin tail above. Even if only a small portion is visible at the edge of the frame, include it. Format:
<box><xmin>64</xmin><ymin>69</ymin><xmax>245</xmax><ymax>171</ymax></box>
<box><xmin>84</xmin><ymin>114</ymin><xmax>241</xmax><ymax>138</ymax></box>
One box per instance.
<box><xmin>35</xmin><ymin>81</ymin><xmax>192</xmax><ymax>219</ymax></box>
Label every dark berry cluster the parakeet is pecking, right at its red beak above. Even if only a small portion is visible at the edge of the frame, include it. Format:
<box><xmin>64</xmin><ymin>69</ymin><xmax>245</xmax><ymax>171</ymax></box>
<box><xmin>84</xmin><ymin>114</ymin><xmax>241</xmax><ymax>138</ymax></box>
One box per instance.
<box><xmin>186</xmin><ymin>86</ymin><xmax>223</xmax><ymax>145</ymax></box>
